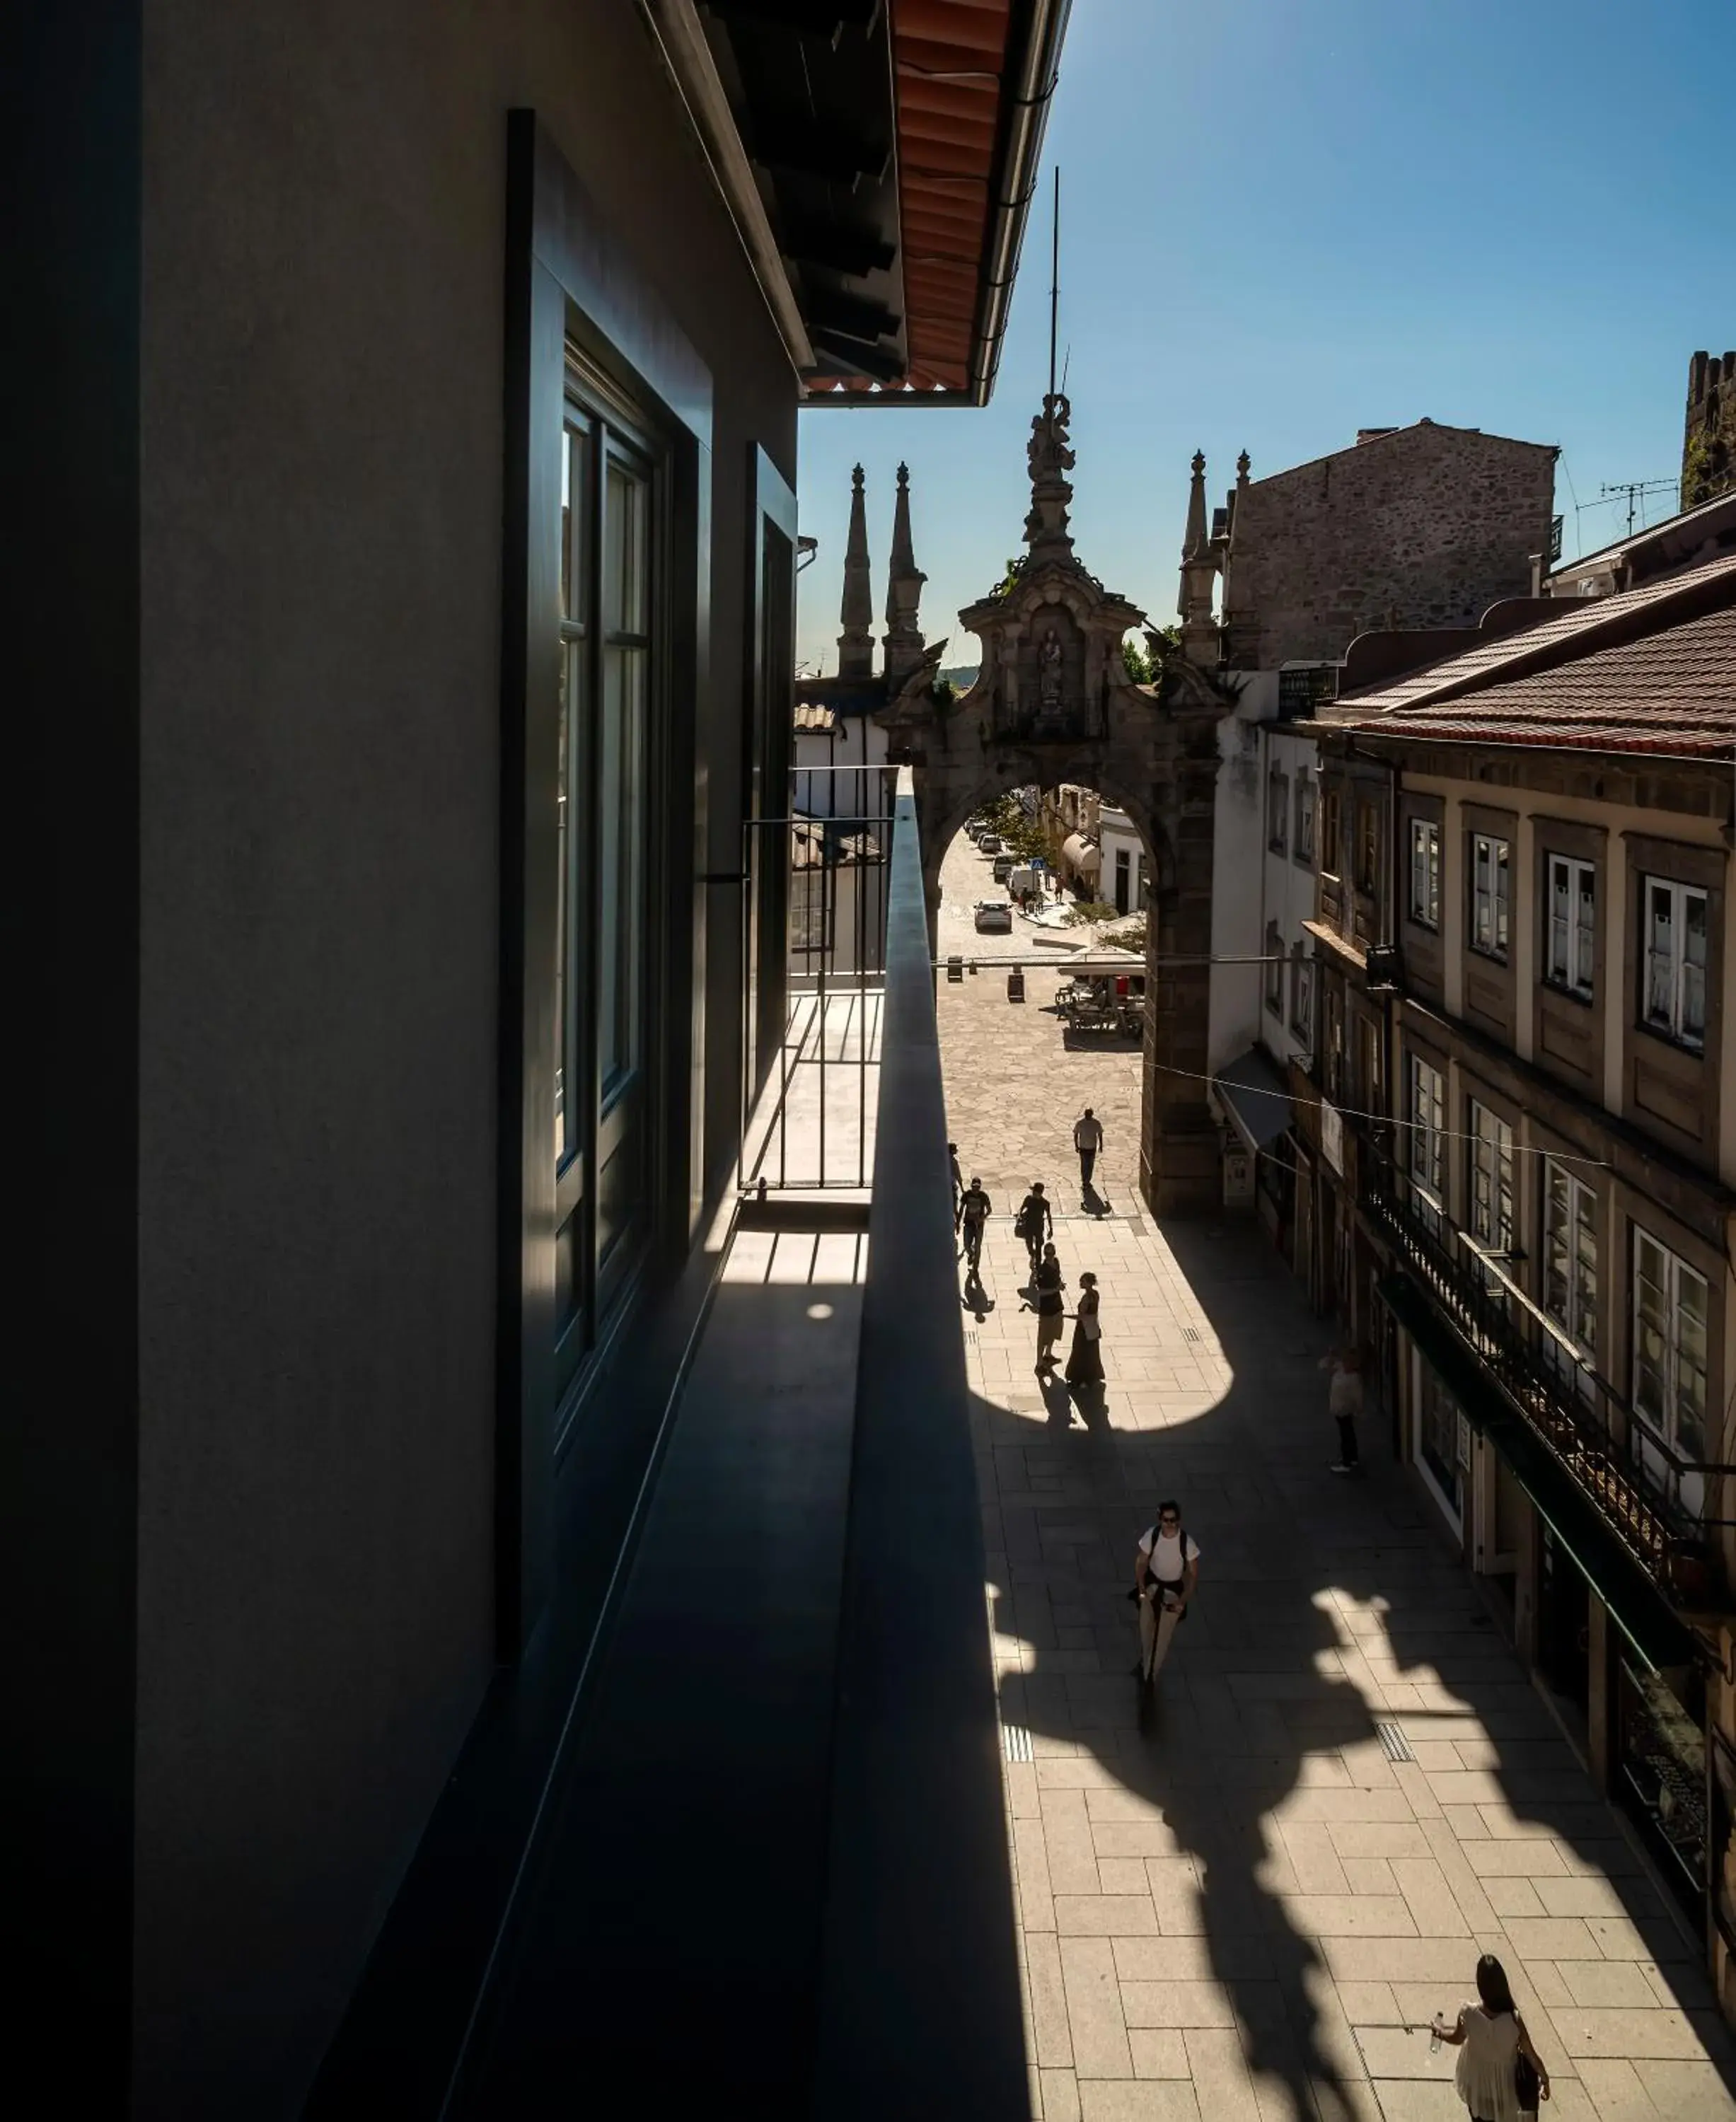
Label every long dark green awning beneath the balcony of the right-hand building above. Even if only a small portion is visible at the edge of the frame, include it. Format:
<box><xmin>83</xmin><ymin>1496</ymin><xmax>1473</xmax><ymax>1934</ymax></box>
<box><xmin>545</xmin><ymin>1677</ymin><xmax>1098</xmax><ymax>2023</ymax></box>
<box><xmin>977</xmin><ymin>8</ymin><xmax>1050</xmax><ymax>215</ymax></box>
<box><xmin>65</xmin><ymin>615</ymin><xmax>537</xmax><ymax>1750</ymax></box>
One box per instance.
<box><xmin>1375</xmin><ymin>1275</ymin><xmax>1696</xmax><ymax>1666</ymax></box>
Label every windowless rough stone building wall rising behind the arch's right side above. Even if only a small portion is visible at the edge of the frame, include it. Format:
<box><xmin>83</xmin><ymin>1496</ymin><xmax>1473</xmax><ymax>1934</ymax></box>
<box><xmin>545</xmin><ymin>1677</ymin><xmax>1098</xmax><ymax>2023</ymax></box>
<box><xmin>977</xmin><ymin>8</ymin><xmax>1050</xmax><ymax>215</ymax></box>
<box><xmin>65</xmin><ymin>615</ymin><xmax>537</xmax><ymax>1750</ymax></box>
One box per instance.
<box><xmin>1222</xmin><ymin>420</ymin><xmax>1556</xmax><ymax>671</ymax></box>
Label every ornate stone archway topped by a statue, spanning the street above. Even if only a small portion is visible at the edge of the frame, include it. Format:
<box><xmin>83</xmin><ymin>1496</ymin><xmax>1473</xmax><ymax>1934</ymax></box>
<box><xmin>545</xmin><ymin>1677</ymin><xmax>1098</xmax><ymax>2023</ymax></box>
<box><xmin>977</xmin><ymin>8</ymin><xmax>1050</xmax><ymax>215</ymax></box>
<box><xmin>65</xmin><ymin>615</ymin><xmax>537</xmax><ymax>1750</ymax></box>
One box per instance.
<box><xmin>881</xmin><ymin>395</ymin><xmax>1235</xmax><ymax>1214</ymax></box>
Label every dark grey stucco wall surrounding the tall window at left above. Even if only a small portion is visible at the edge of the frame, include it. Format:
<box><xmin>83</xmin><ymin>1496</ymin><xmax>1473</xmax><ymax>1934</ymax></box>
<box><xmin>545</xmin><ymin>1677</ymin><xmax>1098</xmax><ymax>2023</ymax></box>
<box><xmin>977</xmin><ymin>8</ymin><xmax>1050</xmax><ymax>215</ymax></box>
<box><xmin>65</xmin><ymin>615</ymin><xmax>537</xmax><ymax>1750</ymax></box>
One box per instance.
<box><xmin>137</xmin><ymin>0</ymin><xmax>796</xmax><ymax>2118</ymax></box>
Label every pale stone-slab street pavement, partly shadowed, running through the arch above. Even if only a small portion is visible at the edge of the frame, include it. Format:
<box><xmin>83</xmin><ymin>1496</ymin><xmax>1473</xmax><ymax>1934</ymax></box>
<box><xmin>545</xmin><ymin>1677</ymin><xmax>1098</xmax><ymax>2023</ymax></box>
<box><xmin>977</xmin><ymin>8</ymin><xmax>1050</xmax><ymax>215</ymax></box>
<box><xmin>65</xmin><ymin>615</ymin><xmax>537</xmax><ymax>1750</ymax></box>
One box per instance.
<box><xmin>940</xmin><ymin>828</ymin><xmax>1736</xmax><ymax>2122</ymax></box>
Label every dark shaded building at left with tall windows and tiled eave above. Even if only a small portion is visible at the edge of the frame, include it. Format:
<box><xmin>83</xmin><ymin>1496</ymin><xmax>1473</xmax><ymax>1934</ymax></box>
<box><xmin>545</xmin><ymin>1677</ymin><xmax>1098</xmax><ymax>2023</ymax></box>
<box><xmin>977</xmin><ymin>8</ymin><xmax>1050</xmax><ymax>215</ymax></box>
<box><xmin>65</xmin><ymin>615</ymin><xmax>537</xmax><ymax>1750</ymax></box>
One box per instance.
<box><xmin>20</xmin><ymin>0</ymin><xmax>1065</xmax><ymax>2122</ymax></box>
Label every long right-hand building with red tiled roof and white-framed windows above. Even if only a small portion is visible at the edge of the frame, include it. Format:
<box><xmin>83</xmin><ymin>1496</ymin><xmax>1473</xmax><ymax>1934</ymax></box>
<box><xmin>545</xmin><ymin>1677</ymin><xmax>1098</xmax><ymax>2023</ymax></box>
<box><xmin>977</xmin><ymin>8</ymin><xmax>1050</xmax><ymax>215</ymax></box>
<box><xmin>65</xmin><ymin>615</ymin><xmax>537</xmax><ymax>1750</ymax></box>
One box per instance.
<box><xmin>1292</xmin><ymin>560</ymin><xmax>1736</xmax><ymax>2001</ymax></box>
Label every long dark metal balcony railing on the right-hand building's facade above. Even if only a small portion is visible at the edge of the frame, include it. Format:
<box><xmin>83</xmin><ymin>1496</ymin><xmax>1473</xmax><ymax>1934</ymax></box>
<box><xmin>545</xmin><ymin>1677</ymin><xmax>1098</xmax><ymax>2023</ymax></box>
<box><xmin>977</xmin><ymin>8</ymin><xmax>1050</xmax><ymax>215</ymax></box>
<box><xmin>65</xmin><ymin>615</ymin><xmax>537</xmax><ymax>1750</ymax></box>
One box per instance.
<box><xmin>1362</xmin><ymin>1152</ymin><xmax>1736</xmax><ymax>1604</ymax></box>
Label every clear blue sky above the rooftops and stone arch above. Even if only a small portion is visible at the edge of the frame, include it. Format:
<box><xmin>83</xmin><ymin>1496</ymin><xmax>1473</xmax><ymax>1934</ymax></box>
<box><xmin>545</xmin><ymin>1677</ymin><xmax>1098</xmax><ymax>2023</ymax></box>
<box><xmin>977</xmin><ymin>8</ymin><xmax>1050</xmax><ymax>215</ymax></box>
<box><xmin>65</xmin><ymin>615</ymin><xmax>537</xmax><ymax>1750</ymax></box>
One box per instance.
<box><xmin>798</xmin><ymin>0</ymin><xmax>1736</xmax><ymax>671</ymax></box>
